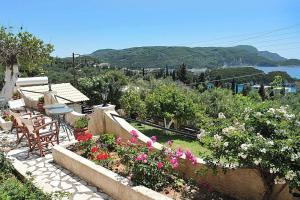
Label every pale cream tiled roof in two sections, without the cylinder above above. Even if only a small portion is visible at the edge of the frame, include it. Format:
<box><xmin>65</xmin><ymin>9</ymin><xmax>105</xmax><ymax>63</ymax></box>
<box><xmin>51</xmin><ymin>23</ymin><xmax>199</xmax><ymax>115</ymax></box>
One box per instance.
<box><xmin>20</xmin><ymin>83</ymin><xmax>89</xmax><ymax>103</ymax></box>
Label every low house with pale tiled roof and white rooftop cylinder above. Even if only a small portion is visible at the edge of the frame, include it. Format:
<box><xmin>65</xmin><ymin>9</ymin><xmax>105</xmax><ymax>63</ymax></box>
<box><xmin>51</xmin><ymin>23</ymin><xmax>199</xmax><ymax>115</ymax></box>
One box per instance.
<box><xmin>16</xmin><ymin>77</ymin><xmax>89</xmax><ymax>113</ymax></box>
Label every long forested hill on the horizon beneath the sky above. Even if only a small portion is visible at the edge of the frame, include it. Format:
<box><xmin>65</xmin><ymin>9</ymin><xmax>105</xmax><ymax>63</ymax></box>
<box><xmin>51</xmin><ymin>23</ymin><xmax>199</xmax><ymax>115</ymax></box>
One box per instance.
<box><xmin>90</xmin><ymin>45</ymin><xmax>300</xmax><ymax>68</ymax></box>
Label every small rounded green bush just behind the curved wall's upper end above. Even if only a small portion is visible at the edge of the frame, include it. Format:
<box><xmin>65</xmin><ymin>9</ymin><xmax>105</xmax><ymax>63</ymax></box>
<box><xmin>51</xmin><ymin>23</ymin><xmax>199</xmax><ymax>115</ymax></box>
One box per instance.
<box><xmin>120</xmin><ymin>89</ymin><xmax>146</xmax><ymax>118</ymax></box>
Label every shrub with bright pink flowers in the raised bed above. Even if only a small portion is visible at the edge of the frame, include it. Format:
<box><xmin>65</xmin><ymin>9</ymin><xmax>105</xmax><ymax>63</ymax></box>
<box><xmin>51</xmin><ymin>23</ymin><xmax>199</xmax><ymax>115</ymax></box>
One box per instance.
<box><xmin>116</xmin><ymin>130</ymin><xmax>196</xmax><ymax>190</ymax></box>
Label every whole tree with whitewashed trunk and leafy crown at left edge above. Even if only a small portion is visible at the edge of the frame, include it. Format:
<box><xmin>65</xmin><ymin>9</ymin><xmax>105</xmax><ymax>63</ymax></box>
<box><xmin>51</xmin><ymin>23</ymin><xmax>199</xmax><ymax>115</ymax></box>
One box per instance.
<box><xmin>0</xmin><ymin>27</ymin><xmax>54</xmax><ymax>99</ymax></box>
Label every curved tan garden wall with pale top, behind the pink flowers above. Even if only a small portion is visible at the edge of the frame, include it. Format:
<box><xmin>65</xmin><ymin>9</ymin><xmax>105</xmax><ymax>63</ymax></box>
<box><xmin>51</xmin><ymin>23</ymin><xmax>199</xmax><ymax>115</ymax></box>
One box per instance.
<box><xmin>88</xmin><ymin>105</ymin><xmax>292</xmax><ymax>200</ymax></box>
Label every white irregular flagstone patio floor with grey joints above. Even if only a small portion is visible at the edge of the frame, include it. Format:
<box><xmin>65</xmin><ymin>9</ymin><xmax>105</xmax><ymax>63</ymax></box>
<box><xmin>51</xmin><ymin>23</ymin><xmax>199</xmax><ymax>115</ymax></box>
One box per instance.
<box><xmin>0</xmin><ymin>127</ymin><xmax>112</xmax><ymax>200</ymax></box>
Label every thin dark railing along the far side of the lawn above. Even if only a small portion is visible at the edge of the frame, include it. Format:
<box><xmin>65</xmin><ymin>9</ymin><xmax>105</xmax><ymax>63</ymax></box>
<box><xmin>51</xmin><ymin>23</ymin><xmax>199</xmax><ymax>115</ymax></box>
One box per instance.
<box><xmin>111</xmin><ymin>113</ymin><xmax>197</xmax><ymax>139</ymax></box>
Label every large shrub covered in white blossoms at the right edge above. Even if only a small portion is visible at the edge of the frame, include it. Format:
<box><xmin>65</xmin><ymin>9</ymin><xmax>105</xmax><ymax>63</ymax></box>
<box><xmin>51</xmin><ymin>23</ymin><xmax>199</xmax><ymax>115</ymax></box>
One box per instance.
<box><xmin>199</xmin><ymin>103</ymin><xmax>300</xmax><ymax>197</ymax></box>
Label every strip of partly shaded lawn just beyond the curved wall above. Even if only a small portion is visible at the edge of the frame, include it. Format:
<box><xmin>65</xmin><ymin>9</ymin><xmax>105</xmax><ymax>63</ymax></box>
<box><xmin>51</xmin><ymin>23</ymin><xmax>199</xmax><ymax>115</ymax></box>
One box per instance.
<box><xmin>131</xmin><ymin>123</ymin><xmax>210</xmax><ymax>158</ymax></box>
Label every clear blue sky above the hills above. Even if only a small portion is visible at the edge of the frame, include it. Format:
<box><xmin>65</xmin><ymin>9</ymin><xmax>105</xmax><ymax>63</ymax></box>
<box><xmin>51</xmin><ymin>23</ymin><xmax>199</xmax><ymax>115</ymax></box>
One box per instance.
<box><xmin>0</xmin><ymin>0</ymin><xmax>300</xmax><ymax>59</ymax></box>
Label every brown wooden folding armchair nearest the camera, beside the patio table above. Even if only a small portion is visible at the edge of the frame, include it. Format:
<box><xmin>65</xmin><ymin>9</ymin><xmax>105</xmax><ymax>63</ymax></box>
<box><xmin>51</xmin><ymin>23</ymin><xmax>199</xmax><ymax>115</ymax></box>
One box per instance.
<box><xmin>22</xmin><ymin>121</ymin><xmax>59</xmax><ymax>157</ymax></box>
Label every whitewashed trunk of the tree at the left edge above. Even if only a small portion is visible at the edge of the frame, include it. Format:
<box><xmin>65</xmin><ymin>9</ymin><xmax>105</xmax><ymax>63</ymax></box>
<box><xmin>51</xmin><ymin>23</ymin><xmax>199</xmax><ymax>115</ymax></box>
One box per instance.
<box><xmin>0</xmin><ymin>64</ymin><xmax>20</xmax><ymax>100</ymax></box>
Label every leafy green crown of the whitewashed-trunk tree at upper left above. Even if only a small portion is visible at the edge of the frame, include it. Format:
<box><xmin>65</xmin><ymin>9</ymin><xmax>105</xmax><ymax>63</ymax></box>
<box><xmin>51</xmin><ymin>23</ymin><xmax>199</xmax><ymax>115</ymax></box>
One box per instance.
<box><xmin>0</xmin><ymin>27</ymin><xmax>53</xmax><ymax>76</ymax></box>
